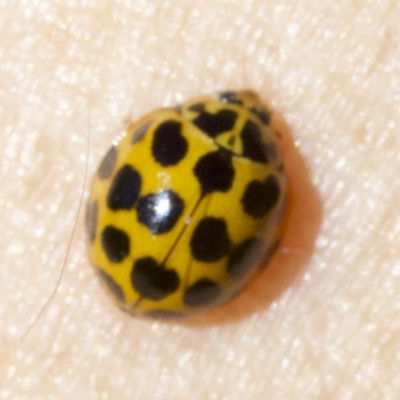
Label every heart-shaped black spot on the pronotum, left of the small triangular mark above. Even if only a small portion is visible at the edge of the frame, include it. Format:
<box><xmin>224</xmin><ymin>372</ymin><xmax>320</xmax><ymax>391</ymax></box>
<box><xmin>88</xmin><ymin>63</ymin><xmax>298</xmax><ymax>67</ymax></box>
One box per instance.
<box><xmin>193</xmin><ymin>109</ymin><xmax>237</xmax><ymax>138</ymax></box>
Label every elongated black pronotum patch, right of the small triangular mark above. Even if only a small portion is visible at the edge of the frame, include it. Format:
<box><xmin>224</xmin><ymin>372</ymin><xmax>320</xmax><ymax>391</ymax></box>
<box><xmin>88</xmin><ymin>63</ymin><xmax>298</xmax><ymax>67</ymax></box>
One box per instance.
<box><xmin>240</xmin><ymin>120</ymin><xmax>268</xmax><ymax>164</ymax></box>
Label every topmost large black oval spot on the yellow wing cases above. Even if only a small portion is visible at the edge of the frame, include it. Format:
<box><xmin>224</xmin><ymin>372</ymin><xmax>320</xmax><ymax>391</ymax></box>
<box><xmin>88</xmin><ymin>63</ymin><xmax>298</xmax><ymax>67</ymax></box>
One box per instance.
<box><xmin>152</xmin><ymin>120</ymin><xmax>188</xmax><ymax>167</ymax></box>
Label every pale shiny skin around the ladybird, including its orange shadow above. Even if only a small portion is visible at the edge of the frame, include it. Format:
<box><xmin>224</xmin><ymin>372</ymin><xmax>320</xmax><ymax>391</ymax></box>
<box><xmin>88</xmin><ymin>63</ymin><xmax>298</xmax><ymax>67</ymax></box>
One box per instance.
<box><xmin>0</xmin><ymin>0</ymin><xmax>400</xmax><ymax>400</ymax></box>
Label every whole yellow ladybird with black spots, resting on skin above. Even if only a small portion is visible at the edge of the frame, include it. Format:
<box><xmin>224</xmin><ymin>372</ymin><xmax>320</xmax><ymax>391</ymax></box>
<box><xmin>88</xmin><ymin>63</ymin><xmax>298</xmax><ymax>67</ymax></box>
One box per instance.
<box><xmin>86</xmin><ymin>90</ymin><xmax>286</xmax><ymax>318</ymax></box>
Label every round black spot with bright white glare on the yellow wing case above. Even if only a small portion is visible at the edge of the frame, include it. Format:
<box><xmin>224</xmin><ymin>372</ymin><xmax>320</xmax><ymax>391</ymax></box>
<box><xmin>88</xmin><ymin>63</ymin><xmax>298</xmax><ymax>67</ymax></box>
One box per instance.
<box><xmin>137</xmin><ymin>190</ymin><xmax>184</xmax><ymax>235</ymax></box>
